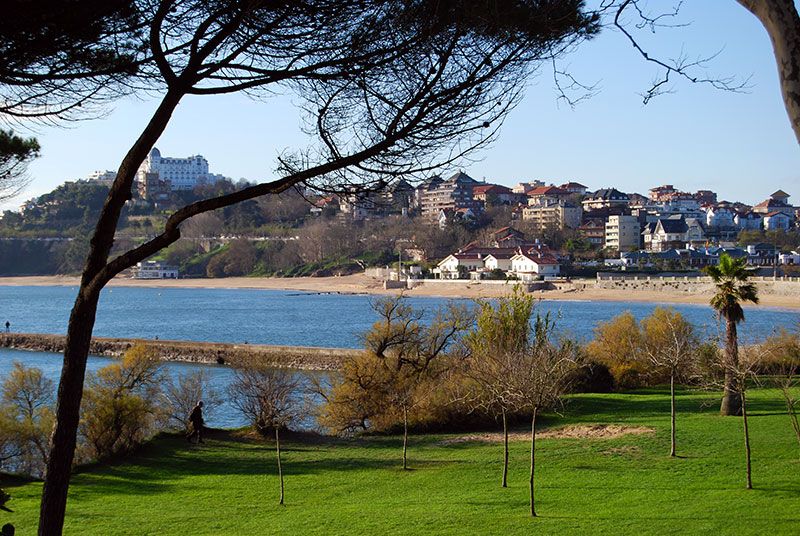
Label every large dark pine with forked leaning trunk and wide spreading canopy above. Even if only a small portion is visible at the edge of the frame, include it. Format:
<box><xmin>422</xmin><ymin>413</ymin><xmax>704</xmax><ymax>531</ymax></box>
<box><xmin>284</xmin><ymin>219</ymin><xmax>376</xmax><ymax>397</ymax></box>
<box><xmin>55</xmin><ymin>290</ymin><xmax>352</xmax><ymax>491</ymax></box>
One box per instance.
<box><xmin>39</xmin><ymin>4</ymin><xmax>597</xmax><ymax>535</ymax></box>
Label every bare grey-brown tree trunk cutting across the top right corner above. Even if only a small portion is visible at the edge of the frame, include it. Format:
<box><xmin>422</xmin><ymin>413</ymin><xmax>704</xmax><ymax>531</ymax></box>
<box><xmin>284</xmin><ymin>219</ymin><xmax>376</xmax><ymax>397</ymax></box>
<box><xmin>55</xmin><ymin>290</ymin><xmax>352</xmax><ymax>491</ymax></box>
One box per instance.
<box><xmin>738</xmin><ymin>0</ymin><xmax>800</xmax><ymax>142</ymax></box>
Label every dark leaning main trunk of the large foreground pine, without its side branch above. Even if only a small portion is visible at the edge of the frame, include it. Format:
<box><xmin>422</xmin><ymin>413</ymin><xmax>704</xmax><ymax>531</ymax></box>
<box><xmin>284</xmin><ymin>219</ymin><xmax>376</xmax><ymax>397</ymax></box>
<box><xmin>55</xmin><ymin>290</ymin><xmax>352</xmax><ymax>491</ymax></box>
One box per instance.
<box><xmin>39</xmin><ymin>92</ymin><xmax>181</xmax><ymax>536</ymax></box>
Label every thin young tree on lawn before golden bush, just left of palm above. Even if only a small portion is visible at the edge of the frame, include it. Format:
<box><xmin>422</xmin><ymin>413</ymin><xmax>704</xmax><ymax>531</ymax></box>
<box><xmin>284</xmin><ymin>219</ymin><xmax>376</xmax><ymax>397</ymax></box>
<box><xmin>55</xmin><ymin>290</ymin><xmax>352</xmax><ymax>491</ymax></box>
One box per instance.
<box><xmin>641</xmin><ymin>307</ymin><xmax>699</xmax><ymax>457</ymax></box>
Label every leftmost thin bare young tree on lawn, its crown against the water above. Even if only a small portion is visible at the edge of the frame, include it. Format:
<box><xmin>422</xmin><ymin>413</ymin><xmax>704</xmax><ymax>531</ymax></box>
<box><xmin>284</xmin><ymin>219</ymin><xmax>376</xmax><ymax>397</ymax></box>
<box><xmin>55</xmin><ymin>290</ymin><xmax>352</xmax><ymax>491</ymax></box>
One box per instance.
<box><xmin>229</xmin><ymin>356</ymin><xmax>303</xmax><ymax>505</ymax></box>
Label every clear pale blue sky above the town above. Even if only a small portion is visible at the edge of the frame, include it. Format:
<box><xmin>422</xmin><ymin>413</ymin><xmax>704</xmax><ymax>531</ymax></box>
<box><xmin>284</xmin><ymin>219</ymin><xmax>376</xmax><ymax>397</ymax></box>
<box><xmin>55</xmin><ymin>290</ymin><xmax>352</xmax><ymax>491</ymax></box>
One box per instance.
<box><xmin>5</xmin><ymin>0</ymin><xmax>800</xmax><ymax>208</ymax></box>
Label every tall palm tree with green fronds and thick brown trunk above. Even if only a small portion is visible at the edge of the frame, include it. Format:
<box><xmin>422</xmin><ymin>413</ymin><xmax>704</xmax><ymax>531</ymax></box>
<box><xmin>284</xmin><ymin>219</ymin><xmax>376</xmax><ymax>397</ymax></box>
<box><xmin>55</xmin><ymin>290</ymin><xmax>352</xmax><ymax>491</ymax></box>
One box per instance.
<box><xmin>705</xmin><ymin>253</ymin><xmax>758</xmax><ymax>415</ymax></box>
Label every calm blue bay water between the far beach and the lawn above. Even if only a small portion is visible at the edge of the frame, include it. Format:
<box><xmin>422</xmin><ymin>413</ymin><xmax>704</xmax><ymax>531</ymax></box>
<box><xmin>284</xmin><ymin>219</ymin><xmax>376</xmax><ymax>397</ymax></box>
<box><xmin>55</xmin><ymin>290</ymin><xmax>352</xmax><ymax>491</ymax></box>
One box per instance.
<box><xmin>0</xmin><ymin>287</ymin><xmax>800</xmax><ymax>427</ymax></box>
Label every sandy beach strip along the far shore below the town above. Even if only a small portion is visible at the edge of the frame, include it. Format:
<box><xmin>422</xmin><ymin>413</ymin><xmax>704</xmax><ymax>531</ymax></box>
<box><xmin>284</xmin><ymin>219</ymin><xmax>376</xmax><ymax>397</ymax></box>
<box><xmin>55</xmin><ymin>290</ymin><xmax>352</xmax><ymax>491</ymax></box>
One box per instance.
<box><xmin>0</xmin><ymin>274</ymin><xmax>800</xmax><ymax>310</ymax></box>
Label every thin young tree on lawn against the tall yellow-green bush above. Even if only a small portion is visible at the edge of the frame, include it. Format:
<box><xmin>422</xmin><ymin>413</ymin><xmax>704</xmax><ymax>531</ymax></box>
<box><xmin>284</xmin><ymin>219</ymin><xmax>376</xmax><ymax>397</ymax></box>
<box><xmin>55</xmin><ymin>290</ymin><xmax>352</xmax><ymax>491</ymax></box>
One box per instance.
<box><xmin>460</xmin><ymin>286</ymin><xmax>534</xmax><ymax>488</ymax></box>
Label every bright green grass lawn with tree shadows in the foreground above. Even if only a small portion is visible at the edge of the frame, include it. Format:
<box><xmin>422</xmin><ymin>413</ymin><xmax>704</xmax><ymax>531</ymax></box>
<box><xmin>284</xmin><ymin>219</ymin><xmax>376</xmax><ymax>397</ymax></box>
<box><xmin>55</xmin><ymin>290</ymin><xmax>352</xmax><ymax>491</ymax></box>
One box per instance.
<box><xmin>0</xmin><ymin>390</ymin><xmax>800</xmax><ymax>535</ymax></box>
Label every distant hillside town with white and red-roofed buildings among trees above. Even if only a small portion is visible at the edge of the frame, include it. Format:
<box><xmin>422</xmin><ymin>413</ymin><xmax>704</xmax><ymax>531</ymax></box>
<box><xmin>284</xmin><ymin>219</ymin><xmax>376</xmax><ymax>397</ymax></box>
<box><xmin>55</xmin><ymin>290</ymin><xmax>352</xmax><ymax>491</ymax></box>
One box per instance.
<box><xmin>0</xmin><ymin>148</ymin><xmax>800</xmax><ymax>281</ymax></box>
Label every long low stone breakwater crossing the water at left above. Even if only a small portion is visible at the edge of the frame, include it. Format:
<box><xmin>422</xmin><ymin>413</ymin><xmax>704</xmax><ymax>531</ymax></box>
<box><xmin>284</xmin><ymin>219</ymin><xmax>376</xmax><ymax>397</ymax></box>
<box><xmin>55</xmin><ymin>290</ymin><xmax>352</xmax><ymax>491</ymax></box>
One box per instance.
<box><xmin>0</xmin><ymin>333</ymin><xmax>361</xmax><ymax>370</ymax></box>
